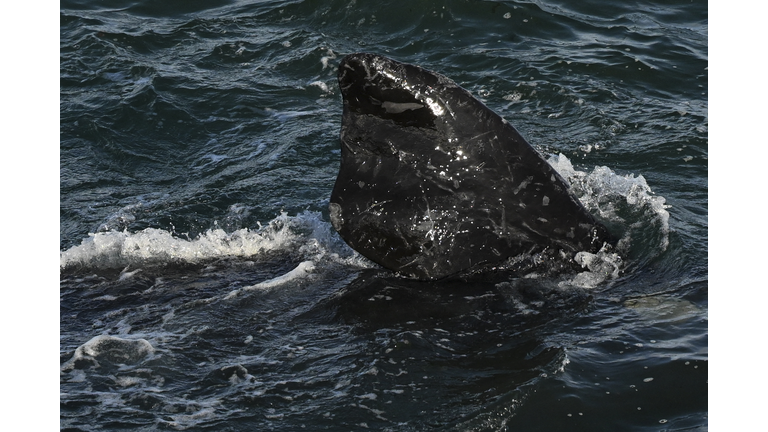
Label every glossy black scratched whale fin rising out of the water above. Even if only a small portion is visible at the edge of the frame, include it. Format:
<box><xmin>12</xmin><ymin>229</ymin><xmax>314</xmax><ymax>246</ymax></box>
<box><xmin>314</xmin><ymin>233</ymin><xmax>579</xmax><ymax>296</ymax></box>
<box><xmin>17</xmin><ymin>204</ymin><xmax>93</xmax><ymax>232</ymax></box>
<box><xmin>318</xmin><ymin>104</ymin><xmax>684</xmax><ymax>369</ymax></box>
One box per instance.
<box><xmin>329</xmin><ymin>53</ymin><xmax>612</xmax><ymax>280</ymax></box>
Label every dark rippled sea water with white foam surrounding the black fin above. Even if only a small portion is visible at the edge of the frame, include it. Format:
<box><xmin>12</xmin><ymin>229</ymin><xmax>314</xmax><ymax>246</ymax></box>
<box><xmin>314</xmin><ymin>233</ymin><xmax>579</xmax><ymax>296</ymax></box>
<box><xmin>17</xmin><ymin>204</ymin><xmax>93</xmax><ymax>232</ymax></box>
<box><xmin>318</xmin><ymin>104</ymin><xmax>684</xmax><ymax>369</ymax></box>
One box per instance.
<box><xmin>59</xmin><ymin>0</ymin><xmax>709</xmax><ymax>431</ymax></box>
